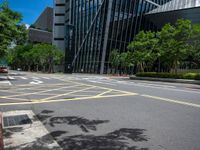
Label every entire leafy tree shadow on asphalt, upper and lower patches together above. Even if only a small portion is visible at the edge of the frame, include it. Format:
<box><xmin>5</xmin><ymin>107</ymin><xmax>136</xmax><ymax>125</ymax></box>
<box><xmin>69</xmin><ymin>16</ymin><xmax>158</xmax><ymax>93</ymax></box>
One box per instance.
<box><xmin>35</xmin><ymin>110</ymin><xmax>149</xmax><ymax>150</ymax></box>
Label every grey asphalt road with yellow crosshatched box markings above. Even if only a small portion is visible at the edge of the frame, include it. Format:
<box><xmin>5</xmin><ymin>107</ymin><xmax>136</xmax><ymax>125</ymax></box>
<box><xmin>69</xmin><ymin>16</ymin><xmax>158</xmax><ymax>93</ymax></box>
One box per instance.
<box><xmin>0</xmin><ymin>72</ymin><xmax>200</xmax><ymax>150</ymax></box>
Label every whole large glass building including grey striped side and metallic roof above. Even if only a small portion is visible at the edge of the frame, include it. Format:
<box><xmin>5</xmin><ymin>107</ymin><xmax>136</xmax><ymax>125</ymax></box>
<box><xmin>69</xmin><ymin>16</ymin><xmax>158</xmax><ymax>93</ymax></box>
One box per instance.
<box><xmin>53</xmin><ymin>0</ymin><xmax>200</xmax><ymax>74</ymax></box>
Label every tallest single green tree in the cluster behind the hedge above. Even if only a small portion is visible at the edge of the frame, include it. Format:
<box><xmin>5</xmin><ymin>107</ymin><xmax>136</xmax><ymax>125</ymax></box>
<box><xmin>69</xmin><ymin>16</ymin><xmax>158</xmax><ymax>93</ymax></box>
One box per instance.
<box><xmin>158</xmin><ymin>19</ymin><xmax>192</xmax><ymax>73</ymax></box>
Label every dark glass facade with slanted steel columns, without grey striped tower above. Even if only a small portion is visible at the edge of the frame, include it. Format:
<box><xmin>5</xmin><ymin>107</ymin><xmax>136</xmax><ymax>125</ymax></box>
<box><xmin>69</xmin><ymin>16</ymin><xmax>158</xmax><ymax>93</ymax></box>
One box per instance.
<box><xmin>53</xmin><ymin>0</ymin><xmax>200</xmax><ymax>73</ymax></box>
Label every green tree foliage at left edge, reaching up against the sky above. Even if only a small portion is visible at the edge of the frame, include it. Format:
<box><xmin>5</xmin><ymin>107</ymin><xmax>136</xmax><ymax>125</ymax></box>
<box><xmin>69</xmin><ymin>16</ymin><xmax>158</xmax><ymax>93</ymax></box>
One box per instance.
<box><xmin>0</xmin><ymin>1</ymin><xmax>27</xmax><ymax>57</ymax></box>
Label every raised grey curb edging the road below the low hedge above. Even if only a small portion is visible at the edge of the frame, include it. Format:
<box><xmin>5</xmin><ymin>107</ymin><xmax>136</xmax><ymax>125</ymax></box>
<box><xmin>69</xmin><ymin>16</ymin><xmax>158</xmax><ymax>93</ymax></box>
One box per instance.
<box><xmin>130</xmin><ymin>76</ymin><xmax>200</xmax><ymax>85</ymax></box>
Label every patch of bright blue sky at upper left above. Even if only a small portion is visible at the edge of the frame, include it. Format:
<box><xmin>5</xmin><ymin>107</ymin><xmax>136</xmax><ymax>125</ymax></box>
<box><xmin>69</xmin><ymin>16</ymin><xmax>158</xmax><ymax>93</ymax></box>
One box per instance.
<box><xmin>0</xmin><ymin>0</ymin><xmax>53</xmax><ymax>26</ymax></box>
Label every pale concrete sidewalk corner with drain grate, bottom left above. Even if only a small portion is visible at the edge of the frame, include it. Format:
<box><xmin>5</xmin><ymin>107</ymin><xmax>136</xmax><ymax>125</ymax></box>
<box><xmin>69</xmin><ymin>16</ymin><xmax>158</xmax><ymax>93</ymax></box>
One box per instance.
<box><xmin>3</xmin><ymin>110</ymin><xmax>61</xmax><ymax>150</ymax></box>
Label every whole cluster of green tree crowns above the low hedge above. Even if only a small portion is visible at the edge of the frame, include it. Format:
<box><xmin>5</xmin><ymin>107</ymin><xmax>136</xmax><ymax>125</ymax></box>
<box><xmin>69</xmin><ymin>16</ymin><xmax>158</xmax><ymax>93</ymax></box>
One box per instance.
<box><xmin>128</xmin><ymin>19</ymin><xmax>200</xmax><ymax>73</ymax></box>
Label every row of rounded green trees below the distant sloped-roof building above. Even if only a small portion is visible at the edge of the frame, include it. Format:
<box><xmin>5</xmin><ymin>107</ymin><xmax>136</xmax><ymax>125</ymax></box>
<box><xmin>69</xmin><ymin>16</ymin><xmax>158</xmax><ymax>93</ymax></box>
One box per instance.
<box><xmin>8</xmin><ymin>44</ymin><xmax>64</xmax><ymax>73</ymax></box>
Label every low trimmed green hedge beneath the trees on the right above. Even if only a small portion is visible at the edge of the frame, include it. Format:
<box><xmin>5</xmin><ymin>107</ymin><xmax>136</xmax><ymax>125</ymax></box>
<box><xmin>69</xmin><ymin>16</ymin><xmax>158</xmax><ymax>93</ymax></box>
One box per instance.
<box><xmin>136</xmin><ymin>72</ymin><xmax>200</xmax><ymax>80</ymax></box>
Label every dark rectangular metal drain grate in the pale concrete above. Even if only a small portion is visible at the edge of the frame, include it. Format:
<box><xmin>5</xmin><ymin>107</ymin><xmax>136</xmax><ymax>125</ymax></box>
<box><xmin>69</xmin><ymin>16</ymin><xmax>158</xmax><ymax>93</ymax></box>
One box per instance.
<box><xmin>3</xmin><ymin>115</ymin><xmax>32</xmax><ymax>127</ymax></box>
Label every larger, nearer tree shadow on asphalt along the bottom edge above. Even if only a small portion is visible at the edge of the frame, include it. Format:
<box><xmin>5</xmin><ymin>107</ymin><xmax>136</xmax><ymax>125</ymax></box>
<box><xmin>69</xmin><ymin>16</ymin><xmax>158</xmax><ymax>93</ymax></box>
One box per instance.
<box><xmin>54</xmin><ymin>128</ymin><xmax>148</xmax><ymax>150</ymax></box>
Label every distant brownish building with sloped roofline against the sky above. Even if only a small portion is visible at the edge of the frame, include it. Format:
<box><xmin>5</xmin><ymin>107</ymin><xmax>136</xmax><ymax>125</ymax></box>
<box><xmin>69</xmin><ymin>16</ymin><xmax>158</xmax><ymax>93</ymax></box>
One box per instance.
<box><xmin>28</xmin><ymin>7</ymin><xmax>53</xmax><ymax>44</ymax></box>
